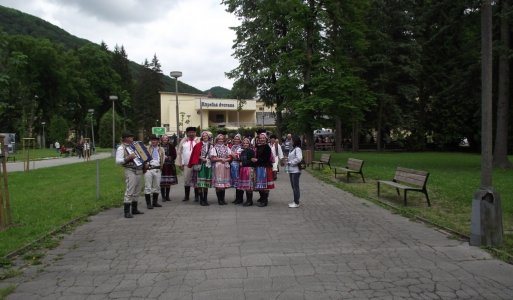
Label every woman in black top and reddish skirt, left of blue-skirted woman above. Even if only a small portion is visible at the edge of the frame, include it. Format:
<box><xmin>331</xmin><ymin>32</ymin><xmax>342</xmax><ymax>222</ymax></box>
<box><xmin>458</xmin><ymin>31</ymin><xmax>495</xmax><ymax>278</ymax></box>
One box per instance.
<box><xmin>235</xmin><ymin>138</ymin><xmax>255</xmax><ymax>206</ymax></box>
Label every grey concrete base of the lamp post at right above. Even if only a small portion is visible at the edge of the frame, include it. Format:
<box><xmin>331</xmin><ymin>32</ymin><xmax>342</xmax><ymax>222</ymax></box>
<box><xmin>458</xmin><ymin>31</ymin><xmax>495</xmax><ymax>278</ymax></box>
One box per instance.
<box><xmin>470</xmin><ymin>189</ymin><xmax>503</xmax><ymax>246</ymax></box>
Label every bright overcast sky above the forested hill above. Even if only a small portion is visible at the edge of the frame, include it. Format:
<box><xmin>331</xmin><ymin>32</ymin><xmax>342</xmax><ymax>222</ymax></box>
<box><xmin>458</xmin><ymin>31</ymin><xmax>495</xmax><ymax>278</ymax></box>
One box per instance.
<box><xmin>0</xmin><ymin>0</ymin><xmax>238</xmax><ymax>91</ymax></box>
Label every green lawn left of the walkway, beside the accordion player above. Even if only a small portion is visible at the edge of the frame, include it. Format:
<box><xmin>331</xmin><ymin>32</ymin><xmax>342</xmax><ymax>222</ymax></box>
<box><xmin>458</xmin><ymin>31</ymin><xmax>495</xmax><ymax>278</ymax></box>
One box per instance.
<box><xmin>0</xmin><ymin>159</ymin><xmax>124</xmax><ymax>257</ymax></box>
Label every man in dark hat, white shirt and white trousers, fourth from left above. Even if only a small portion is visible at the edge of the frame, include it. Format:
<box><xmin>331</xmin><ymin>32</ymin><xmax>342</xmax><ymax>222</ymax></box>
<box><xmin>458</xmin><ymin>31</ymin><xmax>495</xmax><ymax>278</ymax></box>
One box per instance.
<box><xmin>176</xmin><ymin>127</ymin><xmax>199</xmax><ymax>201</ymax></box>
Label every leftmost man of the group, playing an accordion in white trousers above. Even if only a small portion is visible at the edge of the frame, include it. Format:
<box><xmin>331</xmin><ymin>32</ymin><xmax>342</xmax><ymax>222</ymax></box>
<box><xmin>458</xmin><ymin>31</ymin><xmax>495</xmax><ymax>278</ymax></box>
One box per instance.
<box><xmin>116</xmin><ymin>132</ymin><xmax>143</xmax><ymax>218</ymax></box>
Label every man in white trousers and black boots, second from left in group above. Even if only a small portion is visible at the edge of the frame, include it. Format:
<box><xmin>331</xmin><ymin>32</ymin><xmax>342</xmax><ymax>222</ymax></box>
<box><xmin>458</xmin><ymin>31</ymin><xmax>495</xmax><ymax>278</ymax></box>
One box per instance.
<box><xmin>144</xmin><ymin>135</ymin><xmax>164</xmax><ymax>209</ymax></box>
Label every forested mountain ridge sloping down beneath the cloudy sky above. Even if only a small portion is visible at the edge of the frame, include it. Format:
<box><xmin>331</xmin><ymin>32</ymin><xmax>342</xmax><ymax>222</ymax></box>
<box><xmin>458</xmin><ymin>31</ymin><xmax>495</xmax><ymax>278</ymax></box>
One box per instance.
<box><xmin>0</xmin><ymin>5</ymin><xmax>230</xmax><ymax>94</ymax></box>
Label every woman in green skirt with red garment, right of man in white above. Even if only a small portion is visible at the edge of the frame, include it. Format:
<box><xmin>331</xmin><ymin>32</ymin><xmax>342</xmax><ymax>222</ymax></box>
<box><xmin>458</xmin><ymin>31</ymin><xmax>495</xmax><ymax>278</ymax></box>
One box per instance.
<box><xmin>188</xmin><ymin>131</ymin><xmax>212</xmax><ymax>206</ymax></box>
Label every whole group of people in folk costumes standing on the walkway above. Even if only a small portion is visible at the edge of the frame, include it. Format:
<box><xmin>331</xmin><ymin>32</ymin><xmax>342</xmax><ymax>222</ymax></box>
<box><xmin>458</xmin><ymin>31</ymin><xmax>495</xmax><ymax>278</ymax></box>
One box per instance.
<box><xmin>116</xmin><ymin>127</ymin><xmax>303</xmax><ymax>218</ymax></box>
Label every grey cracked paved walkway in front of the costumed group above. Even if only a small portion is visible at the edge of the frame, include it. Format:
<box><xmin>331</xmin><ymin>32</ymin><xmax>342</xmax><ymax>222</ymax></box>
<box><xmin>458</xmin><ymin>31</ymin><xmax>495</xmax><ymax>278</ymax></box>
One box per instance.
<box><xmin>7</xmin><ymin>168</ymin><xmax>513</xmax><ymax>300</ymax></box>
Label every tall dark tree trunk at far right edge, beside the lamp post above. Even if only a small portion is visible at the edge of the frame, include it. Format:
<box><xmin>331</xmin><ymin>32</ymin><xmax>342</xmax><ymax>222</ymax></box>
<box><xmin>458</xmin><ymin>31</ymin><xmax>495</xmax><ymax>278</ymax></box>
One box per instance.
<box><xmin>493</xmin><ymin>0</ymin><xmax>513</xmax><ymax>168</ymax></box>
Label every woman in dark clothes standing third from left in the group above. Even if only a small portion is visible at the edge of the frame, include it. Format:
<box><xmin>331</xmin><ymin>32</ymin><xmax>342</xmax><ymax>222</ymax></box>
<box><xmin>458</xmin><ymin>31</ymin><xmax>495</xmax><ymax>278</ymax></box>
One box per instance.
<box><xmin>160</xmin><ymin>135</ymin><xmax>178</xmax><ymax>202</ymax></box>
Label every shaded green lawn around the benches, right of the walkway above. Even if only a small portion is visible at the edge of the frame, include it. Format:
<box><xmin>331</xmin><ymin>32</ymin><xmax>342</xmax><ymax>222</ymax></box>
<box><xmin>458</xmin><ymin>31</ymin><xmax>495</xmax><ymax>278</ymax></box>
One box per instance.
<box><xmin>308</xmin><ymin>152</ymin><xmax>513</xmax><ymax>255</ymax></box>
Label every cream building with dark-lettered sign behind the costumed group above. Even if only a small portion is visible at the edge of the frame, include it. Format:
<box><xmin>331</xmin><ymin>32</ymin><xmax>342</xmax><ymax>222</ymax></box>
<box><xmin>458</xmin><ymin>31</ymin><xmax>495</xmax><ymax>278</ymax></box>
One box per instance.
<box><xmin>160</xmin><ymin>92</ymin><xmax>276</xmax><ymax>134</ymax></box>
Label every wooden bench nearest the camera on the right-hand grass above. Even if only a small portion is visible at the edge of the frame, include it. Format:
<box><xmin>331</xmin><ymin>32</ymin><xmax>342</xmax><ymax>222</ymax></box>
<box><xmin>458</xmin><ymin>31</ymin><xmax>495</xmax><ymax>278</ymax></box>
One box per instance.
<box><xmin>378</xmin><ymin>167</ymin><xmax>431</xmax><ymax>206</ymax></box>
